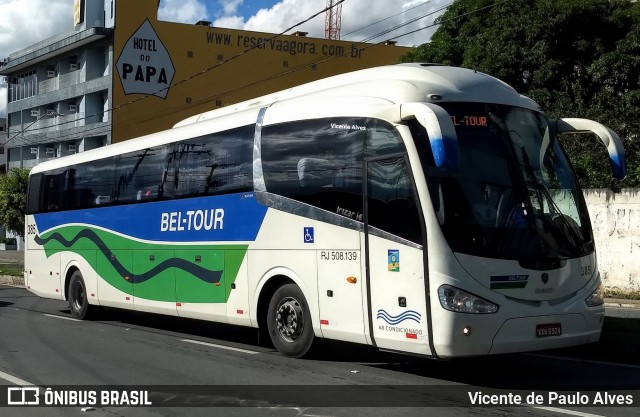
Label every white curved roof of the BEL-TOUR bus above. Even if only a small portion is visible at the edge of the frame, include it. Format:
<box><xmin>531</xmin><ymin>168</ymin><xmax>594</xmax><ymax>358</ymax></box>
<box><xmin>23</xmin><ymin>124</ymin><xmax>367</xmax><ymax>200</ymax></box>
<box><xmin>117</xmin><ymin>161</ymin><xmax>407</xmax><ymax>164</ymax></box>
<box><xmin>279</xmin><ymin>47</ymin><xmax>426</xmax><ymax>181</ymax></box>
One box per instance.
<box><xmin>31</xmin><ymin>64</ymin><xmax>539</xmax><ymax>173</ymax></box>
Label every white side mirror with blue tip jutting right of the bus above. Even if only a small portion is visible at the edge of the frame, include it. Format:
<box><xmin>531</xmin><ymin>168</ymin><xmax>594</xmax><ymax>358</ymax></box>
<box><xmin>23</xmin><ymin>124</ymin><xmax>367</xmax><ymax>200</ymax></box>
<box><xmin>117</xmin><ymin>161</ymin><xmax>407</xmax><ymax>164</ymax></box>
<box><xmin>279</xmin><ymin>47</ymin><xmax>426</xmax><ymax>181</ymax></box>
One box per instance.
<box><xmin>549</xmin><ymin>118</ymin><xmax>627</xmax><ymax>180</ymax></box>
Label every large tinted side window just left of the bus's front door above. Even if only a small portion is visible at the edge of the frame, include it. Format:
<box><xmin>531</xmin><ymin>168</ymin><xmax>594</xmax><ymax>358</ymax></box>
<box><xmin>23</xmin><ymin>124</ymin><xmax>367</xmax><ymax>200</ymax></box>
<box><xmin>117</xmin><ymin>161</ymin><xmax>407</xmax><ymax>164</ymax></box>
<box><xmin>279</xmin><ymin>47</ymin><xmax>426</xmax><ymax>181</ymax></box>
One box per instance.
<box><xmin>261</xmin><ymin>118</ymin><xmax>367</xmax><ymax>220</ymax></box>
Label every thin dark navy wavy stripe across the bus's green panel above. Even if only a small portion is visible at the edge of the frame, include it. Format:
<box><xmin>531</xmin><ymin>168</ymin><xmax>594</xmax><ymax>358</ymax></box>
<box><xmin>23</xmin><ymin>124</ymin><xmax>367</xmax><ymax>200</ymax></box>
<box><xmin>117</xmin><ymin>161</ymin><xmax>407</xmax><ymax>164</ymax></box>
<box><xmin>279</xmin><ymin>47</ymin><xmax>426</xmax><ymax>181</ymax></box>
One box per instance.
<box><xmin>35</xmin><ymin>229</ymin><xmax>223</xmax><ymax>284</ymax></box>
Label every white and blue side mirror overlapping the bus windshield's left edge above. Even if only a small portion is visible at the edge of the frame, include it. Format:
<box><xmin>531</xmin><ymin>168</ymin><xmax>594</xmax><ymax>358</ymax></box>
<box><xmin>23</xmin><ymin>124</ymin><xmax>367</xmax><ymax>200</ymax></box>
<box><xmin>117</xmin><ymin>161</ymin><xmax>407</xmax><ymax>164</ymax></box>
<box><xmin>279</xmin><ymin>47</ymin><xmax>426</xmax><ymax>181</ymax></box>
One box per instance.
<box><xmin>400</xmin><ymin>103</ymin><xmax>460</xmax><ymax>170</ymax></box>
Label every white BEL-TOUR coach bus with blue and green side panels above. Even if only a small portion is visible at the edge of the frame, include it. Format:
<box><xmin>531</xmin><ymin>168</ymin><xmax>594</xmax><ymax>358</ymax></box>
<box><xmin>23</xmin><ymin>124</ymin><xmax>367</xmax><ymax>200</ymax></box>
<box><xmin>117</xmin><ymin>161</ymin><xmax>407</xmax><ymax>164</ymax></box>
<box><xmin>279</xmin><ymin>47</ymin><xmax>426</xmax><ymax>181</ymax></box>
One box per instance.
<box><xmin>25</xmin><ymin>64</ymin><xmax>626</xmax><ymax>358</ymax></box>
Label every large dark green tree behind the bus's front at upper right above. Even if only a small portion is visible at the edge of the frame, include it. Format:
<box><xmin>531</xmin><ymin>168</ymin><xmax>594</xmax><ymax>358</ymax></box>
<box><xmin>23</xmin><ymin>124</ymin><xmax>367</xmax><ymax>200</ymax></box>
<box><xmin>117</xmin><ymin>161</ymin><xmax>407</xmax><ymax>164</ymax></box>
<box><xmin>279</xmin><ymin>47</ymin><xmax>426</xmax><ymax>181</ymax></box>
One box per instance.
<box><xmin>403</xmin><ymin>0</ymin><xmax>640</xmax><ymax>188</ymax></box>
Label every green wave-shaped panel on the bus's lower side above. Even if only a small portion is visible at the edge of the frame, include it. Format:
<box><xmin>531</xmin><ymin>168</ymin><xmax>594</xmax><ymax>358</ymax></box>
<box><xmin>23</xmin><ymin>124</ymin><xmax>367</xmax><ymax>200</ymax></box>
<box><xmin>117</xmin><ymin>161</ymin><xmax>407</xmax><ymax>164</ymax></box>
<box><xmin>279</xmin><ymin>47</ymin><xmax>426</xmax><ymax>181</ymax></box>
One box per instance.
<box><xmin>37</xmin><ymin>226</ymin><xmax>248</xmax><ymax>303</ymax></box>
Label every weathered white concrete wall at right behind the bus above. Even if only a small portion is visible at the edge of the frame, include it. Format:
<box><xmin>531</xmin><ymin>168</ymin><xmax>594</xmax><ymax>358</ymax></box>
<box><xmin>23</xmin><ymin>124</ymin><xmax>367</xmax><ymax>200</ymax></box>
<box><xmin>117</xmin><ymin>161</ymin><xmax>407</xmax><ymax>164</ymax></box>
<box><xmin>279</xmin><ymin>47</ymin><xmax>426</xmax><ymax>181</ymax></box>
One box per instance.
<box><xmin>584</xmin><ymin>188</ymin><xmax>640</xmax><ymax>292</ymax></box>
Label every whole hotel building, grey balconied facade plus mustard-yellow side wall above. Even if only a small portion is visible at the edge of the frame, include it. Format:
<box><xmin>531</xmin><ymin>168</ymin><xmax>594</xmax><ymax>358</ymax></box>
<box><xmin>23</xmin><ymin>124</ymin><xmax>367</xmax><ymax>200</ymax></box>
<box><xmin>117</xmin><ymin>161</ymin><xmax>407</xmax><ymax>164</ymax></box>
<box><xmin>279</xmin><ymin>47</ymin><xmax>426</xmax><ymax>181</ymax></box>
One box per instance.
<box><xmin>0</xmin><ymin>0</ymin><xmax>409</xmax><ymax>166</ymax></box>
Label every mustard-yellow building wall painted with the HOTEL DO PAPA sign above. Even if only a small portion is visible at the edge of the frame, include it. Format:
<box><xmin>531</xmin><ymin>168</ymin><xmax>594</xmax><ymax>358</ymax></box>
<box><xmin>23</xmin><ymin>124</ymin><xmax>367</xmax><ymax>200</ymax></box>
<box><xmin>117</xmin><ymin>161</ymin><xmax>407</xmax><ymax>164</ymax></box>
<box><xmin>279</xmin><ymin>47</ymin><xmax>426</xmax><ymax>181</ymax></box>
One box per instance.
<box><xmin>112</xmin><ymin>0</ymin><xmax>408</xmax><ymax>143</ymax></box>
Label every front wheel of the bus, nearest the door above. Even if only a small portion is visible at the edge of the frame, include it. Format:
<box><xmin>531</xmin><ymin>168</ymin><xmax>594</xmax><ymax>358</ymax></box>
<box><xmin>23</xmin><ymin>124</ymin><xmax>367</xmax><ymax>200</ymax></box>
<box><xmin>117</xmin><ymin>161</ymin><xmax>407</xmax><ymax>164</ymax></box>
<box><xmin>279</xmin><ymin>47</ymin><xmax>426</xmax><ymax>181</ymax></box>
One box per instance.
<box><xmin>267</xmin><ymin>284</ymin><xmax>314</xmax><ymax>358</ymax></box>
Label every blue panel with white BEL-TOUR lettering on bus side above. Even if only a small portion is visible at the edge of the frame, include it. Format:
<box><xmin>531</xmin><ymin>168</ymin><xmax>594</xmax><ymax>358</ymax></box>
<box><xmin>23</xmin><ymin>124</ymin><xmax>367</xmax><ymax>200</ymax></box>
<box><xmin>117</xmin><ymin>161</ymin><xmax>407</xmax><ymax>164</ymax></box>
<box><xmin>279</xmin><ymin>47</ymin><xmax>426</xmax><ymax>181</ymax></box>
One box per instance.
<box><xmin>34</xmin><ymin>193</ymin><xmax>267</xmax><ymax>242</ymax></box>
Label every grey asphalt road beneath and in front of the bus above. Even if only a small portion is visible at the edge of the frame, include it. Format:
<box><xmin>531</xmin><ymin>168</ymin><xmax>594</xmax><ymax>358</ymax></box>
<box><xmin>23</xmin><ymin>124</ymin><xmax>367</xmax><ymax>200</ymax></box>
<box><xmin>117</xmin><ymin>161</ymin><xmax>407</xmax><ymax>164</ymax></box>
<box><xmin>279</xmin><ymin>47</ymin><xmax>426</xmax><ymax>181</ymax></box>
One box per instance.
<box><xmin>0</xmin><ymin>286</ymin><xmax>640</xmax><ymax>417</ymax></box>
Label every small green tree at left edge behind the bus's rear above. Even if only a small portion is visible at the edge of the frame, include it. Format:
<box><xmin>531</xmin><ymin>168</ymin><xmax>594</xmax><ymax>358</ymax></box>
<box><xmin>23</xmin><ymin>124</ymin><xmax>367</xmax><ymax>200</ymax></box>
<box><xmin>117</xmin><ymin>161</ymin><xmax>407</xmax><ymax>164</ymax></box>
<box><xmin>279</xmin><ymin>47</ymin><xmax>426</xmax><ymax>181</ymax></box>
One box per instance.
<box><xmin>0</xmin><ymin>168</ymin><xmax>29</xmax><ymax>237</ymax></box>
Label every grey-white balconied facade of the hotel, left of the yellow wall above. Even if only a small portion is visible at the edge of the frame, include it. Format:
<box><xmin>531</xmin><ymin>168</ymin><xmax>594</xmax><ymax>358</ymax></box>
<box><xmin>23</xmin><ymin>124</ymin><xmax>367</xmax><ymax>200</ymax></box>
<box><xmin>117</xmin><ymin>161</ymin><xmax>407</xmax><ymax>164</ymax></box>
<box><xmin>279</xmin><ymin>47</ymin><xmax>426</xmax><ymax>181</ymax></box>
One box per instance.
<box><xmin>0</xmin><ymin>0</ymin><xmax>114</xmax><ymax>171</ymax></box>
